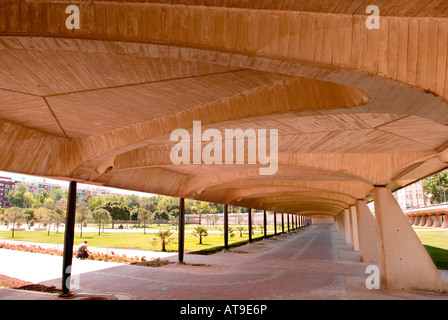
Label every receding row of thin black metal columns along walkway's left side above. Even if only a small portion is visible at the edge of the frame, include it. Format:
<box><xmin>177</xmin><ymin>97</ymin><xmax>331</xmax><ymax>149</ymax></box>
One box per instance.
<box><xmin>62</xmin><ymin>181</ymin><xmax>311</xmax><ymax>295</ymax></box>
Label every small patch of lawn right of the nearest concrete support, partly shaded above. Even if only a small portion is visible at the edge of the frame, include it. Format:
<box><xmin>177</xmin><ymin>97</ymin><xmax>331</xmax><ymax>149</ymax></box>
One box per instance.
<box><xmin>415</xmin><ymin>228</ymin><xmax>448</xmax><ymax>270</ymax></box>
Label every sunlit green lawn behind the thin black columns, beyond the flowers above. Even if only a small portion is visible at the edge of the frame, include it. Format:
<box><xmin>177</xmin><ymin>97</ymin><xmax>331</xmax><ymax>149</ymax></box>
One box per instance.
<box><xmin>0</xmin><ymin>231</ymin><xmax>263</xmax><ymax>251</ymax></box>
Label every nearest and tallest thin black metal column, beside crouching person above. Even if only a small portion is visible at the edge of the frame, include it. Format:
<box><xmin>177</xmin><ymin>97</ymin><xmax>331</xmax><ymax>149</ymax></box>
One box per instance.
<box><xmin>62</xmin><ymin>181</ymin><xmax>76</xmax><ymax>296</ymax></box>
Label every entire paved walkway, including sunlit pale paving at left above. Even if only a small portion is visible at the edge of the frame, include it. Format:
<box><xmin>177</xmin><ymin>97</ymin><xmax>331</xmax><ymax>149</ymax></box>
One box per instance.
<box><xmin>0</xmin><ymin>225</ymin><xmax>448</xmax><ymax>300</ymax></box>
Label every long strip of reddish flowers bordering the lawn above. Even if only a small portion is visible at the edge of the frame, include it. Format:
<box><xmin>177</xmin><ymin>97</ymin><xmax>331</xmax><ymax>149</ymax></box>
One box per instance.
<box><xmin>0</xmin><ymin>242</ymin><xmax>169</xmax><ymax>267</ymax></box>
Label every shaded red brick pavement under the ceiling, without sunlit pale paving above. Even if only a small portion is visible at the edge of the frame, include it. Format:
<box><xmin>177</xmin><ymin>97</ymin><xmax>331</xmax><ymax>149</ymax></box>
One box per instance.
<box><xmin>36</xmin><ymin>226</ymin><xmax>365</xmax><ymax>300</ymax></box>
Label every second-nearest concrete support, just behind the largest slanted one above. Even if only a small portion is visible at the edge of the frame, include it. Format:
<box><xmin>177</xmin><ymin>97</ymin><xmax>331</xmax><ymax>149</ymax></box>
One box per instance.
<box><xmin>356</xmin><ymin>200</ymin><xmax>379</xmax><ymax>263</ymax></box>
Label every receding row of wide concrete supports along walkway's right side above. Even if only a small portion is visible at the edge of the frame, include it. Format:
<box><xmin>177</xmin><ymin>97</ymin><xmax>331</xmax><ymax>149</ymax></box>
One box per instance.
<box><xmin>334</xmin><ymin>186</ymin><xmax>448</xmax><ymax>292</ymax></box>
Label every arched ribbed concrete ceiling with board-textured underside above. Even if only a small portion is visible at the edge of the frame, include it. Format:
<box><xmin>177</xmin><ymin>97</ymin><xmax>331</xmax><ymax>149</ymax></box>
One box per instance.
<box><xmin>0</xmin><ymin>0</ymin><xmax>448</xmax><ymax>216</ymax></box>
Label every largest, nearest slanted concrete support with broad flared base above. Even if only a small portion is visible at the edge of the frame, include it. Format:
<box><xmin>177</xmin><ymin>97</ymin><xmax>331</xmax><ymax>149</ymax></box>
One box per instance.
<box><xmin>373</xmin><ymin>187</ymin><xmax>448</xmax><ymax>292</ymax></box>
